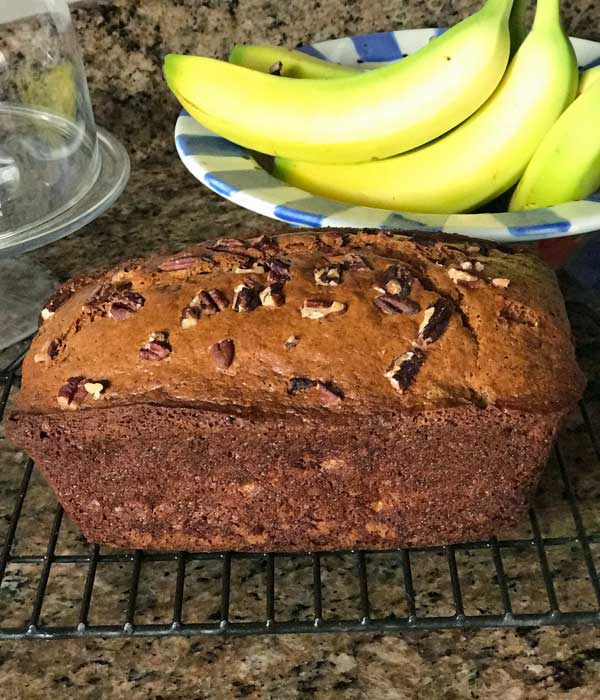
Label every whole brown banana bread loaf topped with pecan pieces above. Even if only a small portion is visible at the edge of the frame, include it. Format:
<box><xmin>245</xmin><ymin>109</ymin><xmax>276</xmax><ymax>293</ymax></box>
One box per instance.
<box><xmin>7</xmin><ymin>230</ymin><xmax>583</xmax><ymax>551</ymax></box>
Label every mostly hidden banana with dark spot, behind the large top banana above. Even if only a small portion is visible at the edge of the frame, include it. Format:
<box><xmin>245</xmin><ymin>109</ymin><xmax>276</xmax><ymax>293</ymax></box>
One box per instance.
<box><xmin>229</xmin><ymin>44</ymin><xmax>364</xmax><ymax>79</ymax></box>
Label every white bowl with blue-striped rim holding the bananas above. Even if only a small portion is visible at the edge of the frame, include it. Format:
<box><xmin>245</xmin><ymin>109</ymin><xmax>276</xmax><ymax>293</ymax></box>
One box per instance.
<box><xmin>175</xmin><ymin>29</ymin><xmax>600</xmax><ymax>241</ymax></box>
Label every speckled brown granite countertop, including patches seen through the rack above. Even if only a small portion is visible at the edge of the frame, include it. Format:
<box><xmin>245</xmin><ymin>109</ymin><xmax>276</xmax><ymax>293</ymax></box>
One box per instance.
<box><xmin>0</xmin><ymin>0</ymin><xmax>600</xmax><ymax>700</ymax></box>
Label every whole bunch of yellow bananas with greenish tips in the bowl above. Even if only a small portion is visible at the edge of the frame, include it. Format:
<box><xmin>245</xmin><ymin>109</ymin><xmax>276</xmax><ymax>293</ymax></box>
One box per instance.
<box><xmin>165</xmin><ymin>0</ymin><xmax>600</xmax><ymax>214</ymax></box>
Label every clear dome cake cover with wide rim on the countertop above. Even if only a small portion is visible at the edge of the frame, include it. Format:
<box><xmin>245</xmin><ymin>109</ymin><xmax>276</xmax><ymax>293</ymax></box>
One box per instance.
<box><xmin>0</xmin><ymin>0</ymin><xmax>129</xmax><ymax>253</ymax></box>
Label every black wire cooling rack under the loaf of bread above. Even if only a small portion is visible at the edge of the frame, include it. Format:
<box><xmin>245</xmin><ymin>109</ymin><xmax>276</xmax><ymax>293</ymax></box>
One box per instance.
<box><xmin>0</xmin><ymin>336</ymin><xmax>600</xmax><ymax>639</ymax></box>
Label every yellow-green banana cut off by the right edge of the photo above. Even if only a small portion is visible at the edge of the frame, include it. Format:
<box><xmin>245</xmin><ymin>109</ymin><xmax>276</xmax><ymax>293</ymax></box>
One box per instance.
<box><xmin>509</xmin><ymin>80</ymin><xmax>600</xmax><ymax>211</ymax></box>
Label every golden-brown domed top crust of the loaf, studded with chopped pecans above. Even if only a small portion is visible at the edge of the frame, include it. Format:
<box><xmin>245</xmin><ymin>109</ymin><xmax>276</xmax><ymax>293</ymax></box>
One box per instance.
<box><xmin>16</xmin><ymin>230</ymin><xmax>583</xmax><ymax>422</ymax></box>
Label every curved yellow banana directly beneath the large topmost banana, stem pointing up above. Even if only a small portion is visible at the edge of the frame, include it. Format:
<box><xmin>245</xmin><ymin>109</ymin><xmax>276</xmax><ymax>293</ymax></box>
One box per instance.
<box><xmin>274</xmin><ymin>0</ymin><xmax>578</xmax><ymax>214</ymax></box>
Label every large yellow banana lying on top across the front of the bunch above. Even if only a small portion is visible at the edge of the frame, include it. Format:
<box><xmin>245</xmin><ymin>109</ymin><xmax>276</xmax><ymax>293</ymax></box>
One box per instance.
<box><xmin>164</xmin><ymin>0</ymin><xmax>513</xmax><ymax>163</ymax></box>
